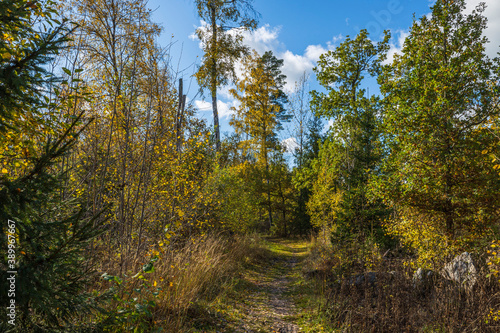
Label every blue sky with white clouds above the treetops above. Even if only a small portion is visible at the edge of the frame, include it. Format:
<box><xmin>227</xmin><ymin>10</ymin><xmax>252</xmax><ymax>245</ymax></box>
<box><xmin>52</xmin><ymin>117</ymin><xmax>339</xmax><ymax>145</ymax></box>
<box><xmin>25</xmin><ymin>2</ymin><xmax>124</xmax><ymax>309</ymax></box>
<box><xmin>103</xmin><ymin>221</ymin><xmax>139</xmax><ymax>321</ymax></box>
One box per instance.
<box><xmin>149</xmin><ymin>0</ymin><xmax>500</xmax><ymax>148</ymax></box>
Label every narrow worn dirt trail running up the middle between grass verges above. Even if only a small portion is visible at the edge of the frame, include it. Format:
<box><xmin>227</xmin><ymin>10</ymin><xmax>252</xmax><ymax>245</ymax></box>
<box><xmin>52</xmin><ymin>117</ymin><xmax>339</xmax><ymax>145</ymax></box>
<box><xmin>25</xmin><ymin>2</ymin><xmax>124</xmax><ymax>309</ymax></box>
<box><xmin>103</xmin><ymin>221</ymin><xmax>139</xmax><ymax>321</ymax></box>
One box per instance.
<box><xmin>229</xmin><ymin>240</ymin><xmax>307</xmax><ymax>333</ymax></box>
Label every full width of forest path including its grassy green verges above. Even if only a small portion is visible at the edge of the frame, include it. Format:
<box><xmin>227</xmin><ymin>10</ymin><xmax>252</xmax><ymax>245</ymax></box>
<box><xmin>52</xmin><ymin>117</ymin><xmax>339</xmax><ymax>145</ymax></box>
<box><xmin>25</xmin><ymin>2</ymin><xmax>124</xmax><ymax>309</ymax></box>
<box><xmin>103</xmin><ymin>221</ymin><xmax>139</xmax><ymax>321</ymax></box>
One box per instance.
<box><xmin>194</xmin><ymin>239</ymin><xmax>331</xmax><ymax>333</ymax></box>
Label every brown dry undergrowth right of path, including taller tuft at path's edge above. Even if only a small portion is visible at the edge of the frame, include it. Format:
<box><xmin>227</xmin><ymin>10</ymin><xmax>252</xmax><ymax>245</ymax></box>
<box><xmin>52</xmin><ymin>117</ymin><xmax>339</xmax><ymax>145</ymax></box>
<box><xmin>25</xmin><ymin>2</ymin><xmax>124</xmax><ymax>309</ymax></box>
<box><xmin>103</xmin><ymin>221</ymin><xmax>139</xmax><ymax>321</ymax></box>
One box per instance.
<box><xmin>302</xmin><ymin>235</ymin><xmax>500</xmax><ymax>332</ymax></box>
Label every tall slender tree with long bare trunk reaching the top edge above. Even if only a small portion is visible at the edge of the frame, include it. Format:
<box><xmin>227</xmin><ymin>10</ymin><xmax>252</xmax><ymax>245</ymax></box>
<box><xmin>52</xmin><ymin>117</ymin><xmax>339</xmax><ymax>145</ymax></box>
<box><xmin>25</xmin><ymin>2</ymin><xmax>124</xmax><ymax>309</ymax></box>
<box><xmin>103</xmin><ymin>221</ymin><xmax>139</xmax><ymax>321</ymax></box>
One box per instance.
<box><xmin>196</xmin><ymin>0</ymin><xmax>257</xmax><ymax>151</ymax></box>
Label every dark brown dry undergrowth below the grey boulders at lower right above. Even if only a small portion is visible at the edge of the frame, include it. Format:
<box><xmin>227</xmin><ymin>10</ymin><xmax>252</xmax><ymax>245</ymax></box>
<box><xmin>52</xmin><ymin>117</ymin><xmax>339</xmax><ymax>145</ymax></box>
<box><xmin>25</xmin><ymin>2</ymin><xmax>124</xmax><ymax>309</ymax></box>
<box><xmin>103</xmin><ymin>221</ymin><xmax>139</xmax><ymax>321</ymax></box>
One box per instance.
<box><xmin>327</xmin><ymin>260</ymin><xmax>500</xmax><ymax>332</ymax></box>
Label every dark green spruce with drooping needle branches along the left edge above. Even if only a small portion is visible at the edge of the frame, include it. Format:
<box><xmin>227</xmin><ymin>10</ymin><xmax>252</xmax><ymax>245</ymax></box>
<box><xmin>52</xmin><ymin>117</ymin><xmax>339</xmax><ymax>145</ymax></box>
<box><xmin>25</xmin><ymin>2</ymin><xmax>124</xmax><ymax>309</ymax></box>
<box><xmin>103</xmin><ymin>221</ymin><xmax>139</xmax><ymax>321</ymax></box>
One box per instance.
<box><xmin>0</xmin><ymin>0</ymin><xmax>106</xmax><ymax>332</ymax></box>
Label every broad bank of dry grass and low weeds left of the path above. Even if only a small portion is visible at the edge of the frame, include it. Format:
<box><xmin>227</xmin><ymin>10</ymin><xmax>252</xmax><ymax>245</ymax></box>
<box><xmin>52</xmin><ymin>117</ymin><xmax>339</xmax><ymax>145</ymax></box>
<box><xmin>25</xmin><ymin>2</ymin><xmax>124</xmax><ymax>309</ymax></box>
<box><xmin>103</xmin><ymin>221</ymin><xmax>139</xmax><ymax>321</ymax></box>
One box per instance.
<box><xmin>89</xmin><ymin>234</ymin><xmax>266</xmax><ymax>332</ymax></box>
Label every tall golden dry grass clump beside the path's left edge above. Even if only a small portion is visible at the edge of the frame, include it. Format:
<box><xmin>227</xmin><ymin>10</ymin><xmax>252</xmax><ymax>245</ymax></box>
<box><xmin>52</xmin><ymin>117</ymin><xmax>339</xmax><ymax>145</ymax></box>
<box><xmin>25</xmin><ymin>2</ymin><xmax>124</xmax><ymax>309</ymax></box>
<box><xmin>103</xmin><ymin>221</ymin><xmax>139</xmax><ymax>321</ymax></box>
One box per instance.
<box><xmin>152</xmin><ymin>232</ymin><xmax>266</xmax><ymax>331</ymax></box>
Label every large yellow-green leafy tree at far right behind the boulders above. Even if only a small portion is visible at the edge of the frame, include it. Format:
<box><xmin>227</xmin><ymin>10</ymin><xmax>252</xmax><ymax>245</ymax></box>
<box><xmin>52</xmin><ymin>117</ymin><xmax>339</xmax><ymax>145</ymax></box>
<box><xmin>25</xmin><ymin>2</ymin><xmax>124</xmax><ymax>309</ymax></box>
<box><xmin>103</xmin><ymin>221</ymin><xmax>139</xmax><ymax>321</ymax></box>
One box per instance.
<box><xmin>375</xmin><ymin>0</ymin><xmax>500</xmax><ymax>259</ymax></box>
